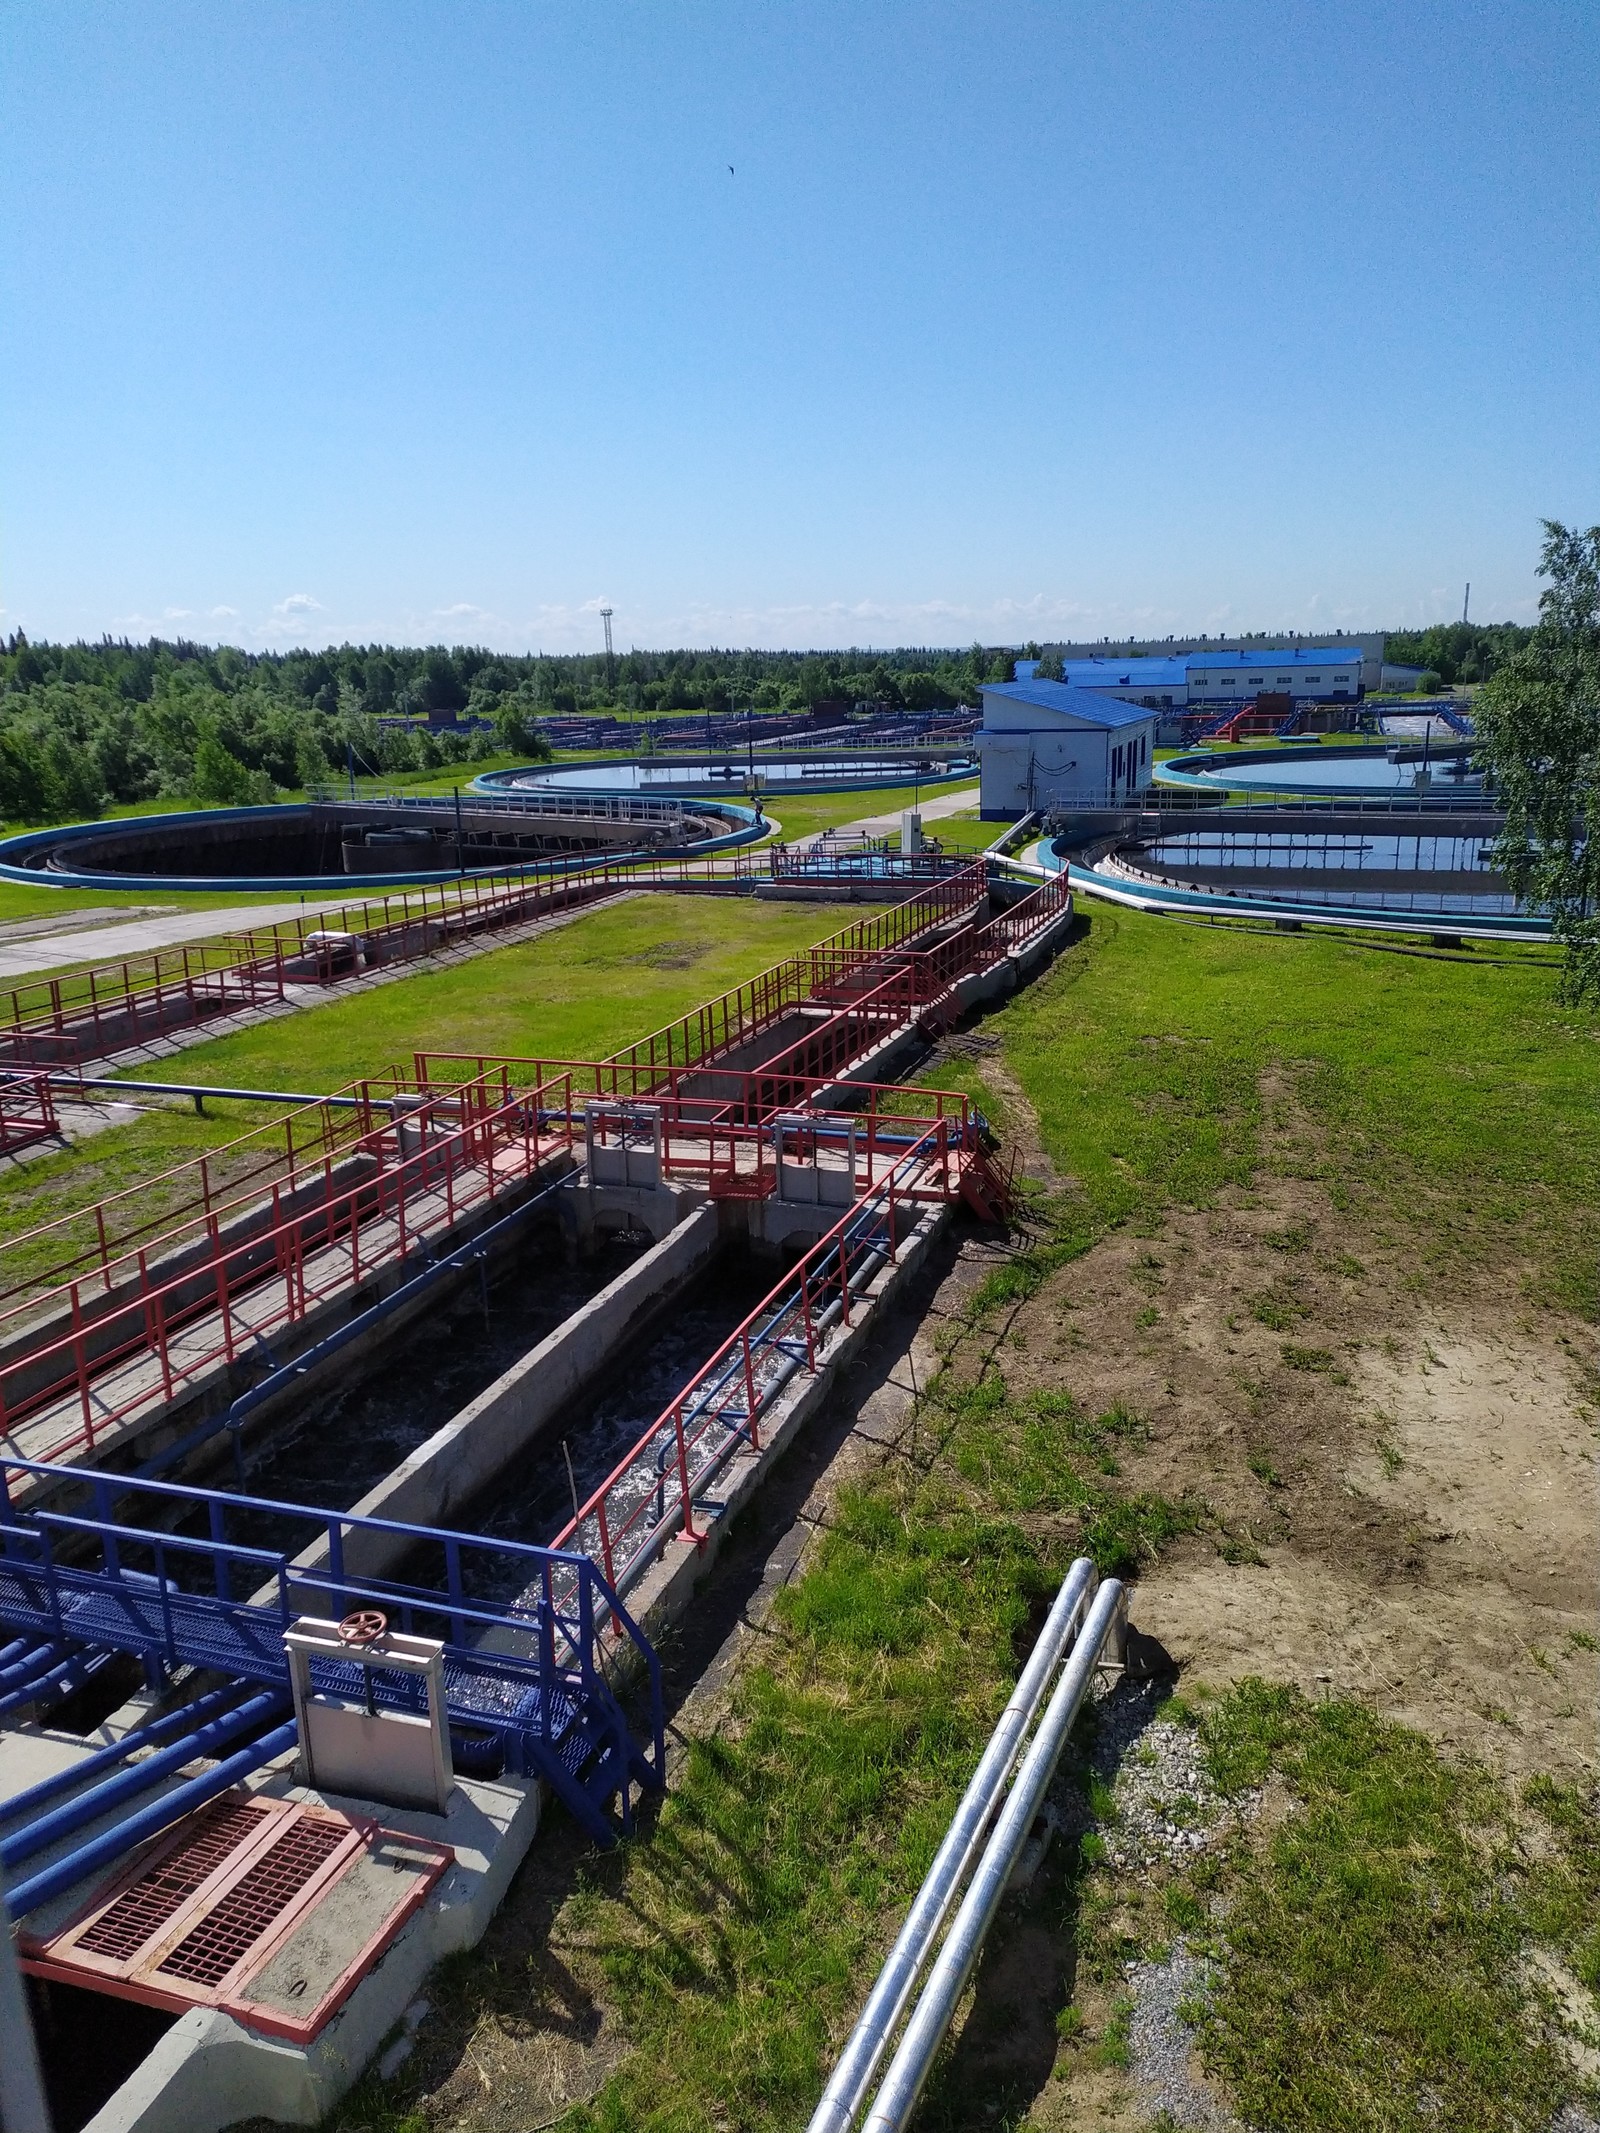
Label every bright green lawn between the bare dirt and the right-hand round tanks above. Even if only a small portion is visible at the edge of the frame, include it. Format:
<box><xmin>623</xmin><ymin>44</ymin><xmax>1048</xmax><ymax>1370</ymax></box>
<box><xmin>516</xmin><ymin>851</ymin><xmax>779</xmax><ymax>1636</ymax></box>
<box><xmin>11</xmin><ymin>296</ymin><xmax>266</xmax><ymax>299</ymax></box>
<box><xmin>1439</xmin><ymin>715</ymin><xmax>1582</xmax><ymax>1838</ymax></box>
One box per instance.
<box><xmin>994</xmin><ymin>904</ymin><xmax>1600</xmax><ymax>1316</ymax></box>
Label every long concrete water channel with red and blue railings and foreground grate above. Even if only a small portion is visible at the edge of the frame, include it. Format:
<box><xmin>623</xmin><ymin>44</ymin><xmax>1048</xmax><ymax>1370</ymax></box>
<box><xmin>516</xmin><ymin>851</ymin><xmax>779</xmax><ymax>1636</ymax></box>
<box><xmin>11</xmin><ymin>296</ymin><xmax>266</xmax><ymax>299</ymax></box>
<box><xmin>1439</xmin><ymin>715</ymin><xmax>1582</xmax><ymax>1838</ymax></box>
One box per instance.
<box><xmin>0</xmin><ymin>868</ymin><xmax>1071</xmax><ymax>2133</ymax></box>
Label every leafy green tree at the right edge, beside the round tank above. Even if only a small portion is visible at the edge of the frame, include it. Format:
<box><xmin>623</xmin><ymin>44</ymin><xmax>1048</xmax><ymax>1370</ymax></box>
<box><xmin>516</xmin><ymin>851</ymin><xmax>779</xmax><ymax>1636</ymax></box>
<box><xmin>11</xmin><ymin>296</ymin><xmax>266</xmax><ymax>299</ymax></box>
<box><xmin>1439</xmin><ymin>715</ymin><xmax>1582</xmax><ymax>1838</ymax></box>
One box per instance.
<box><xmin>1474</xmin><ymin>518</ymin><xmax>1600</xmax><ymax>1000</ymax></box>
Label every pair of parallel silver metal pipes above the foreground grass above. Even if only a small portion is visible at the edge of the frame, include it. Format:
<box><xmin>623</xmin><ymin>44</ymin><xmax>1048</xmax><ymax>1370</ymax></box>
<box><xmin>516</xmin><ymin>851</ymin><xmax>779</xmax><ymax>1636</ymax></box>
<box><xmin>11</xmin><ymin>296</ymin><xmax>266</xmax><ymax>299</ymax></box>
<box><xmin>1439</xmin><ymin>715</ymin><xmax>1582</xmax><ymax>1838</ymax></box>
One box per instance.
<box><xmin>809</xmin><ymin>1557</ymin><xmax>1126</xmax><ymax>2133</ymax></box>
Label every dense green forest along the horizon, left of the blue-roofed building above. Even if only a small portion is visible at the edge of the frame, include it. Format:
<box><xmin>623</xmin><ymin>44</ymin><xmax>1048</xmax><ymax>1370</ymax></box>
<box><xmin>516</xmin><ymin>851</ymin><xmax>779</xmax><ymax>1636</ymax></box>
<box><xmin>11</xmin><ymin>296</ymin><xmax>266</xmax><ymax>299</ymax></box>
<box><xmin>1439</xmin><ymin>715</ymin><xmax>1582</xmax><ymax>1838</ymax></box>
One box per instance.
<box><xmin>0</xmin><ymin>631</ymin><xmax>1011</xmax><ymax>821</ymax></box>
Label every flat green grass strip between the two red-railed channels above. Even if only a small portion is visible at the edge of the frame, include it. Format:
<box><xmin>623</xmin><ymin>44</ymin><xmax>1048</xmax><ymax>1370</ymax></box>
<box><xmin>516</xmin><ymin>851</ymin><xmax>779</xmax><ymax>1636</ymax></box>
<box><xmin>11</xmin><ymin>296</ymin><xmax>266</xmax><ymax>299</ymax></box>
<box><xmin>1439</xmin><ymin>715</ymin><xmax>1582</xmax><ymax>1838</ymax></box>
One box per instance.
<box><xmin>0</xmin><ymin>896</ymin><xmax>855</xmax><ymax>1280</ymax></box>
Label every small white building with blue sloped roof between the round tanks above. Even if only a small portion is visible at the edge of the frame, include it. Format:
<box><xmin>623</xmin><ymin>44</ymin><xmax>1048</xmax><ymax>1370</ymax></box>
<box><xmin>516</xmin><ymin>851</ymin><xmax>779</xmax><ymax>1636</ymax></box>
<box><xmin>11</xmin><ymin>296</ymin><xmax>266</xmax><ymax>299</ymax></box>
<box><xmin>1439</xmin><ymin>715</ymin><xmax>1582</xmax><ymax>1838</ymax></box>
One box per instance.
<box><xmin>977</xmin><ymin>682</ymin><xmax>1156</xmax><ymax>821</ymax></box>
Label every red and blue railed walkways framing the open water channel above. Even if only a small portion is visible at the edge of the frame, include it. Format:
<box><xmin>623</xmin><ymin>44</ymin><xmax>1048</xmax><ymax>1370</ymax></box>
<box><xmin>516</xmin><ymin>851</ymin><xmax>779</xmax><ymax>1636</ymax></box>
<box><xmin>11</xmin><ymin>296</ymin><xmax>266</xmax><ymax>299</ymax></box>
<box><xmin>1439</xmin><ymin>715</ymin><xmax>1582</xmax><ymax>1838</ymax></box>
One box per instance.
<box><xmin>0</xmin><ymin>864</ymin><xmax>1071</xmax><ymax>1909</ymax></box>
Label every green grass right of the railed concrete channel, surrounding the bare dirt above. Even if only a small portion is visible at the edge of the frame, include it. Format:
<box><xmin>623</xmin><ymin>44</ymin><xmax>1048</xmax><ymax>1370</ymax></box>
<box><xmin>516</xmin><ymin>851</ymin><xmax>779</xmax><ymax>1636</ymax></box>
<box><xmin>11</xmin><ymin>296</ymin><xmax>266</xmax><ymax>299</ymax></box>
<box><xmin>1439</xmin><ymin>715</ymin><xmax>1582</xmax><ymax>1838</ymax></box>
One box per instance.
<box><xmin>335</xmin><ymin>911</ymin><xmax>1600</xmax><ymax>2133</ymax></box>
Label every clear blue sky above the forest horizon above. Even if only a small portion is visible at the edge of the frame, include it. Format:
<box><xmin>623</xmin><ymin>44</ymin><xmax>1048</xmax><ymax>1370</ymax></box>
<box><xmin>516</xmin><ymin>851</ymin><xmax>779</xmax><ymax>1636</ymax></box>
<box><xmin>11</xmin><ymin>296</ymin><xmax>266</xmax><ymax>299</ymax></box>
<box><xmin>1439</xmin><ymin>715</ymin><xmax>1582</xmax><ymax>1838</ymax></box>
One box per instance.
<box><xmin>0</xmin><ymin>0</ymin><xmax>1600</xmax><ymax>651</ymax></box>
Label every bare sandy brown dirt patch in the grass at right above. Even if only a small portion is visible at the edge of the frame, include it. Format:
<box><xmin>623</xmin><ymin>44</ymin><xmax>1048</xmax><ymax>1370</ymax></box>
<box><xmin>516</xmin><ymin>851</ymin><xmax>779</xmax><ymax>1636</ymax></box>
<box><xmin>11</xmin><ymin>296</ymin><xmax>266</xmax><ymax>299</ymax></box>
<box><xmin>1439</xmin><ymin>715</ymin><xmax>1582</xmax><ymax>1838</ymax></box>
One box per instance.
<box><xmin>1001</xmin><ymin>1143</ymin><xmax>1600</xmax><ymax>1775</ymax></box>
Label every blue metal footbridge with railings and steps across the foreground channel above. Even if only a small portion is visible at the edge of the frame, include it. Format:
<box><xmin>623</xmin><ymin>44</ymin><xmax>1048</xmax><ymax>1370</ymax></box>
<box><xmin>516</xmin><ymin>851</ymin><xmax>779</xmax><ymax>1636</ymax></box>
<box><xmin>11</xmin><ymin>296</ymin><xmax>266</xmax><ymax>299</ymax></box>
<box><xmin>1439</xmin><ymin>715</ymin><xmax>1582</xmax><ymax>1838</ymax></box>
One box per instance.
<box><xmin>0</xmin><ymin>1459</ymin><xmax>663</xmax><ymax>1841</ymax></box>
